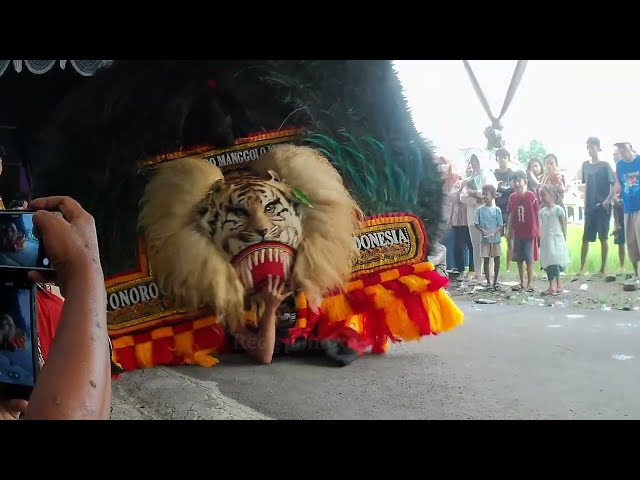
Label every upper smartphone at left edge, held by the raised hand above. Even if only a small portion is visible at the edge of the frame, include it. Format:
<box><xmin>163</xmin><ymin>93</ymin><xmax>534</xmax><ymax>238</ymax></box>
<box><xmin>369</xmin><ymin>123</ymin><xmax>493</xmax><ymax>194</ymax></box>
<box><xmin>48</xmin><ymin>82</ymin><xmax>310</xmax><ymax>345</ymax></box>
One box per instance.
<box><xmin>0</xmin><ymin>210</ymin><xmax>62</xmax><ymax>272</ymax></box>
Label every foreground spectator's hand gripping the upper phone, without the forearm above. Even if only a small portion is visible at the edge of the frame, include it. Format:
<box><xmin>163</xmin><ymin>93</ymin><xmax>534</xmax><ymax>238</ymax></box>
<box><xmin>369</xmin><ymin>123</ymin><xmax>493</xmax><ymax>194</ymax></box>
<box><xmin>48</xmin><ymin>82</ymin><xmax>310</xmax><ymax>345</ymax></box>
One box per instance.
<box><xmin>29</xmin><ymin>197</ymin><xmax>104</xmax><ymax>296</ymax></box>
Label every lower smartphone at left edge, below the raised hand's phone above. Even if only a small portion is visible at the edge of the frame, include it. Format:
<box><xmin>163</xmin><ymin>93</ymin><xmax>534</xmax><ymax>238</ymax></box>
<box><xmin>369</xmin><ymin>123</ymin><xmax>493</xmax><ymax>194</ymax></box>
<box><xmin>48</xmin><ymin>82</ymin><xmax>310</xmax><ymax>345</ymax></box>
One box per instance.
<box><xmin>0</xmin><ymin>282</ymin><xmax>40</xmax><ymax>400</ymax></box>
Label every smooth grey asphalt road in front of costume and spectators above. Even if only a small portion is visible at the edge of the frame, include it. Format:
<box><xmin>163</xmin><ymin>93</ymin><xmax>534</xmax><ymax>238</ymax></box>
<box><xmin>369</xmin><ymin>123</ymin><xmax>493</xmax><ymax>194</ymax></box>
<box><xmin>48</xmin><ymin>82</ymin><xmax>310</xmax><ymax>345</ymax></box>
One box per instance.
<box><xmin>173</xmin><ymin>302</ymin><xmax>640</xmax><ymax>419</ymax></box>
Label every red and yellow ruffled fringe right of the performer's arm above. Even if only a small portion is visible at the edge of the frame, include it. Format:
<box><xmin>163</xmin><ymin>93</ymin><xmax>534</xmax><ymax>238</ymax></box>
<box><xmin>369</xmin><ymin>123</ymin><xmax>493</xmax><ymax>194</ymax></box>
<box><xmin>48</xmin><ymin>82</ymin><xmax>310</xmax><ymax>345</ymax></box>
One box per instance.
<box><xmin>278</xmin><ymin>262</ymin><xmax>464</xmax><ymax>353</ymax></box>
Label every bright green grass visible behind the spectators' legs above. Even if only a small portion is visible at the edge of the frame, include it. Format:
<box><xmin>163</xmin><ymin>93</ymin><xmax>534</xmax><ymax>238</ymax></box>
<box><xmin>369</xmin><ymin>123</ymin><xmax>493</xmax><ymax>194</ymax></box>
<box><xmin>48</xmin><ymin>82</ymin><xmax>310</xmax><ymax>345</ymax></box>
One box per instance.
<box><xmin>500</xmin><ymin>225</ymin><xmax>633</xmax><ymax>274</ymax></box>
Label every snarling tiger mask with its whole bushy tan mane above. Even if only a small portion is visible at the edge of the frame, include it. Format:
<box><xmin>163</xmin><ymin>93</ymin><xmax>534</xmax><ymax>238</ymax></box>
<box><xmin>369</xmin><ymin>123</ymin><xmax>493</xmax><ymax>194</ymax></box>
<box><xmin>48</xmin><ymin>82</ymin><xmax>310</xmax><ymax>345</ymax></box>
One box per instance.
<box><xmin>139</xmin><ymin>145</ymin><xmax>362</xmax><ymax>334</ymax></box>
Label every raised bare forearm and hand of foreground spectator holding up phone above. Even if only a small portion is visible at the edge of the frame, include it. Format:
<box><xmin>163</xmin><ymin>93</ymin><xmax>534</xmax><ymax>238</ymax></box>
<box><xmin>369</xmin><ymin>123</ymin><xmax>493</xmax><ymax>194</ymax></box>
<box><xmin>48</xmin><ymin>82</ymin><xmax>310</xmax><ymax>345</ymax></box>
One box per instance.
<box><xmin>24</xmin><ymin>197</ymin><xmax>111</xmax><ymax>420</ymax></box>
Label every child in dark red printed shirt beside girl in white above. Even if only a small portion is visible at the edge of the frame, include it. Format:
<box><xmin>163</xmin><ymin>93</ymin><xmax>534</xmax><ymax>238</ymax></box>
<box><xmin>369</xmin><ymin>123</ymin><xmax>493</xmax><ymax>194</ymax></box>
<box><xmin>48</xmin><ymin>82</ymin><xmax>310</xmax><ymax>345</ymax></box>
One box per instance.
<box><xmin>507</xmin><ymin>171</ymin><xmax>540</xmax><ymax>292</ymax></box>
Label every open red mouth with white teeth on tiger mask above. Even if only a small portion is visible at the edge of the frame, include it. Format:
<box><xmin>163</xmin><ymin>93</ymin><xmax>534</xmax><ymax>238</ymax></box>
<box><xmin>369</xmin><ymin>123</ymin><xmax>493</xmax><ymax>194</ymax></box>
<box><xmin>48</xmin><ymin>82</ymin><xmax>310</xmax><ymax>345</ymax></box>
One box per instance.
<box><xmin>231</xmin><ymin>242</ymin><xmax>296</xmax><ymax>291</ymax></box>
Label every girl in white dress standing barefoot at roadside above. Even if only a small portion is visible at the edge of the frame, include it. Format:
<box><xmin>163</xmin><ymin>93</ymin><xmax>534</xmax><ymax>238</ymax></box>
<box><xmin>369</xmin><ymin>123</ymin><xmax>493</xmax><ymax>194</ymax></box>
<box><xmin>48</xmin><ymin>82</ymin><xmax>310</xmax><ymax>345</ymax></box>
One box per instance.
<box><xmin>539</xmin><ymin>184</ymin><xmax>569</xmax><ymax>295</ymax></box>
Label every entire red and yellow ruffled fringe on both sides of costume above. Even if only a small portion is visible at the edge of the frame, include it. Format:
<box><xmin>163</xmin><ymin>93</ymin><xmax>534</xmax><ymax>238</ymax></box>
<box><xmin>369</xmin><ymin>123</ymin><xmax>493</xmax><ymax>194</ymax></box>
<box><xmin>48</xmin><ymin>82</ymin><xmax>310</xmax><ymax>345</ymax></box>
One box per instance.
<box><xmin>112</xmin><ymin>262</ymin><xmax>464</xmax><ymax>371</ymax></box>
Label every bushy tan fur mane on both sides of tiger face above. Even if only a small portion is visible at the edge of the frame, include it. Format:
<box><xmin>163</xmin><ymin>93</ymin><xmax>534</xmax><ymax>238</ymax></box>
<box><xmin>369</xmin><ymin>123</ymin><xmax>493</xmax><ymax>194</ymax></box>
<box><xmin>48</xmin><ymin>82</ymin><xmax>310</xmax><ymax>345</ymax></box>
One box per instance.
<box><xmin>138</xmin><ymin>145</ymin><xmax>363</xmax><ymax>330</ymax></box>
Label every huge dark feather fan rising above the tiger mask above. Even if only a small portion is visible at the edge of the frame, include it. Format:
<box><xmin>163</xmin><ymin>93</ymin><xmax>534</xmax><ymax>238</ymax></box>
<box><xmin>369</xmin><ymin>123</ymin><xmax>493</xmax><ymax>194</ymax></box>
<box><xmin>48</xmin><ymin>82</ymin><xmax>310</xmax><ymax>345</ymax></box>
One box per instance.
<box><xmin>34</xmin><ymin>60</ymin><xmax>441</xmax><ymax>274</ymax></box>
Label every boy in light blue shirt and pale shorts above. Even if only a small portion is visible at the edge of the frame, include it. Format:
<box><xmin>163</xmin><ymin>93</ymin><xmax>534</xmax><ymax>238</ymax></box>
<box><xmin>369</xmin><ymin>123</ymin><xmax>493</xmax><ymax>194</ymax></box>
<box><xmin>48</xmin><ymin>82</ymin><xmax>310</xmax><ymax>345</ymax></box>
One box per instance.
<box><xmin>475</xmin><ymin>185</ymin><xmax>504</xmax><ymax>290</ymax></box>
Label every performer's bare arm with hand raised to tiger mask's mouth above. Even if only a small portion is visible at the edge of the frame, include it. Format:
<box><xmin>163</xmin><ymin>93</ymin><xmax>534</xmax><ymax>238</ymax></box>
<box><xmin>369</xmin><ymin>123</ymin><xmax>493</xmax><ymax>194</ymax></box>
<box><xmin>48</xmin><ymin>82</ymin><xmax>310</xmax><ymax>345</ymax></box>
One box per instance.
<box><xmin>233</xmin><ymin>275</ymin><xmax>289</xmax><ymax>365</ymax></box>
